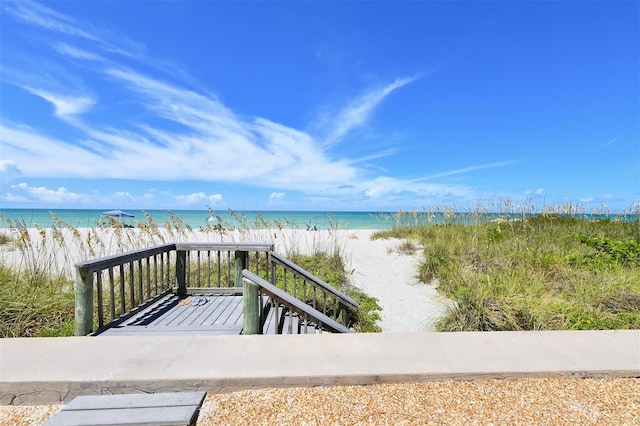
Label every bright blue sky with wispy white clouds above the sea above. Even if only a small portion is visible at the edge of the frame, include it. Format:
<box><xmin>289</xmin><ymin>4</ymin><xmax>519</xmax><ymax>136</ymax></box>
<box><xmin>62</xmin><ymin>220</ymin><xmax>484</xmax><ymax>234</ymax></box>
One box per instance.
<box><xmin>0</xmin><ymin>1</ymin><xmax>640</xmax><ymax>211</ymax></box>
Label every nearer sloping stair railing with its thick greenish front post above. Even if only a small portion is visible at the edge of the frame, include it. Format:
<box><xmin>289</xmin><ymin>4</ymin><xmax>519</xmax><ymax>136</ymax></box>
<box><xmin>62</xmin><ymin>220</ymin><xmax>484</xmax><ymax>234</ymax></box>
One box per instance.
<box><xmin>242</xmin><ymin>269</ymin><xmax>353</xmax><ymax>334</ymax></box>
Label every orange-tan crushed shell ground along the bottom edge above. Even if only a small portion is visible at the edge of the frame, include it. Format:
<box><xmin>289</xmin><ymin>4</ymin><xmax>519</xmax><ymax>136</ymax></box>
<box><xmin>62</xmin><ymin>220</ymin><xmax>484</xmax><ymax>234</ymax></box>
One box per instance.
<box><xmin>0</xmin><ymin>378</ymin><xmax>640</xmax><ymax>426</ymax></box>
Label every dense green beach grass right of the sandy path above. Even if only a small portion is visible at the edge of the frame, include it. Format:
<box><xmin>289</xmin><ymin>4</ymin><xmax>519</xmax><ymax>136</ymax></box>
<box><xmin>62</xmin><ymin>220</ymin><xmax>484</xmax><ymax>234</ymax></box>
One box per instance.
<box><xmin>373</xmin><ymin>201</ymin><xmax>640</xmax><ymax>331</ymax></box>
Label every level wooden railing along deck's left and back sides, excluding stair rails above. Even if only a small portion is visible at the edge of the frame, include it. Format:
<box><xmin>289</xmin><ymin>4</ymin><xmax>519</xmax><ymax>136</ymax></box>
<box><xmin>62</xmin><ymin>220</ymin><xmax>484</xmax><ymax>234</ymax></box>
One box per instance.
<box><xmin>75</xmin><ymin>242</ymin><xmax>273</xmax><ymax>336</ymax></box>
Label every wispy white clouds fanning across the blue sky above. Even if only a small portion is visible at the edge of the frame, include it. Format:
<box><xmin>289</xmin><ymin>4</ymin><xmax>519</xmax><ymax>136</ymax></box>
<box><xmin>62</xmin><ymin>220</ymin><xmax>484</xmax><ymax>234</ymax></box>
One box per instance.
<box><xmin>0</xmin><ymin>2</ymin><xmax>476</xmax><ymax>209</ymax></box>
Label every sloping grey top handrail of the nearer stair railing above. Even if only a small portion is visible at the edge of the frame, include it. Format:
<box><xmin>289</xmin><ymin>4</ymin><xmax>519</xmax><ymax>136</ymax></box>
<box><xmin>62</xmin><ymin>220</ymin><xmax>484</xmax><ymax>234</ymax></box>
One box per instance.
<box><xmin>242</xmin><ymin>269</ymin><xmax>353</xmax><ymax>333</ymax></box>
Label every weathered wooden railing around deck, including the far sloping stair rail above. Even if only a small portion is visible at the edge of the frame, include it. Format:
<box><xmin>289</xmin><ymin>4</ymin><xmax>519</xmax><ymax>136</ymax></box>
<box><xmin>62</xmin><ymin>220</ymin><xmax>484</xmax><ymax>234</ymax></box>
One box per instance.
<box><xmin>75</xmin><ymin>243</ymin><xmax>358</xmax><ymax>336</ymax></box>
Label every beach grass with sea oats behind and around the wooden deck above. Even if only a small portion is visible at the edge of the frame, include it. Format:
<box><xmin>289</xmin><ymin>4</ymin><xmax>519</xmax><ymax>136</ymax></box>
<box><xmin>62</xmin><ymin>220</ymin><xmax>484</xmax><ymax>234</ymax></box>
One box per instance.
<box><xmin>0</xmin><ymin>210</ymin><xmax>381</xmax><ymax>337</ymax></box>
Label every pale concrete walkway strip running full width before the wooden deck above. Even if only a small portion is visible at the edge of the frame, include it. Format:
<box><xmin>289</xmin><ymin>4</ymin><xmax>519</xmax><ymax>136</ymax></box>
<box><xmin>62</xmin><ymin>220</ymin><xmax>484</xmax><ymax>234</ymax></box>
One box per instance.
<box><xmin>0</xmin><ymin>330</ymin><xmax>640</xmax><ymax>405</ymax></box>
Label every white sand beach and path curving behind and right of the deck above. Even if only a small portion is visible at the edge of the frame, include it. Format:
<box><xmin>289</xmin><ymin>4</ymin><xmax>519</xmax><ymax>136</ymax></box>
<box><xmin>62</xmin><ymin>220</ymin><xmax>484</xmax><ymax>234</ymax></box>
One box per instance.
<box><xmin>0</xmin><ymin>228</ymin><xmax>451</xmax><ymax>332</ymax></box>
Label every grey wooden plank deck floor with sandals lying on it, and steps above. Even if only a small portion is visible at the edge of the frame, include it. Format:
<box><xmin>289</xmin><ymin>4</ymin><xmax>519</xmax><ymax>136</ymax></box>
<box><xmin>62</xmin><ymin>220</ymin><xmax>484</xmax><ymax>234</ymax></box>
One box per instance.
<box><xmin>97</xmin><ymin>288</ymin><xmax>317</xmax><ymax>336</ymax></box>
